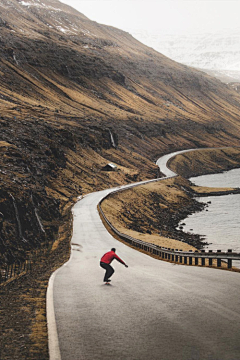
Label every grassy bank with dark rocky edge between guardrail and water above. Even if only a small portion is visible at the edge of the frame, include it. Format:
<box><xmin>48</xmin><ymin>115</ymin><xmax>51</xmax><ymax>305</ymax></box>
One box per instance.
<box><xmin>101</xmin><ymin>177</ymin><xmax>210</xmax><ymax>251</ymax></box>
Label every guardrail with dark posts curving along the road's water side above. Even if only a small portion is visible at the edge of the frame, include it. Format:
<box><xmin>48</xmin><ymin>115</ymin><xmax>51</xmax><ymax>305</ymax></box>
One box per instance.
<box><xmin>98</xmin><ymin>183</ymin><xmax>240</xmax><ymax>269</ymax></box>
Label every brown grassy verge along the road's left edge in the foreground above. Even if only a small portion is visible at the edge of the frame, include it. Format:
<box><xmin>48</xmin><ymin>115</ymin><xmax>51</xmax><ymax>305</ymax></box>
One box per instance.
<box><xmin>0</xmin><ymin>214</ymin><xmax>71</xmax><ymax>360</ymax></box>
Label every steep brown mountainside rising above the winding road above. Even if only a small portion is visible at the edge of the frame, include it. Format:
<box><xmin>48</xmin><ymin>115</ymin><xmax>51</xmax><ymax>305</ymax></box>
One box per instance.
<box><xmin>0</xmin><ymin>0</ymin><xmax>240</xmax><ymax>263</ymax></box>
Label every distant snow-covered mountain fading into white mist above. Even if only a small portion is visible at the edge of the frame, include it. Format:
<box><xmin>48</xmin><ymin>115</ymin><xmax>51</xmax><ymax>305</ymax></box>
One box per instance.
<box><xmin>130</xmin><ymin>30</ymin><xmax>240</xmax><ymax>82</ymax></box>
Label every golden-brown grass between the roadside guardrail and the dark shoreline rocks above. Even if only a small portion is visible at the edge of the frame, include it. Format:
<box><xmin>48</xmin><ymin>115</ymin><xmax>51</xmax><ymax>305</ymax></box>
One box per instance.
<box><xmin>102</xmin><ymin>178</ymin><xmax>196</xmax><ymax>251</ymax></box>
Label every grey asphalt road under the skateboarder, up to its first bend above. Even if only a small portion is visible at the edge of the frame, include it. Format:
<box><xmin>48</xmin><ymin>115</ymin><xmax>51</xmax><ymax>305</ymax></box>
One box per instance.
<box><xmin>47</xmin><ymin>149</ymin><xmax>240</xmax><ymax>360</ymax></box>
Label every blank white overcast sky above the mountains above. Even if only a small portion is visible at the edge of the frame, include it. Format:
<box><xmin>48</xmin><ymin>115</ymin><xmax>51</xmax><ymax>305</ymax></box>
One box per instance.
<box><xmin>61</xmin><ymin>0</ymin><xmax>240</xmax><ymax>34</ymax></box>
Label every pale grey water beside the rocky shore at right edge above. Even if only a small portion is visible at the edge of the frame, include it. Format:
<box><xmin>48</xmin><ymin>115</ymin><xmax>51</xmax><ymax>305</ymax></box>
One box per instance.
<box><xmin>179</xmin><ymin>169</ymin><xmax>240</xmax><ymax>252</ymax></box>
